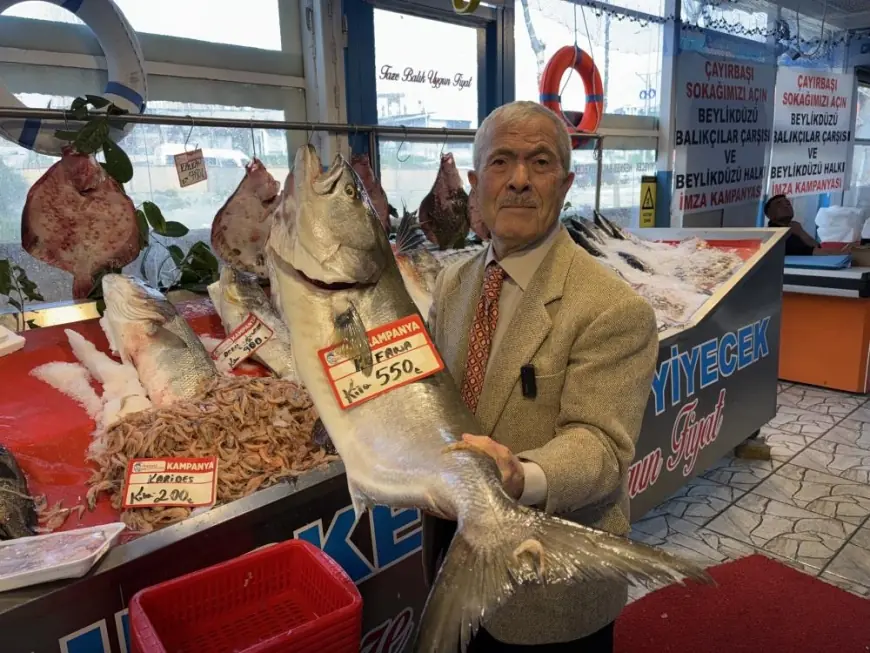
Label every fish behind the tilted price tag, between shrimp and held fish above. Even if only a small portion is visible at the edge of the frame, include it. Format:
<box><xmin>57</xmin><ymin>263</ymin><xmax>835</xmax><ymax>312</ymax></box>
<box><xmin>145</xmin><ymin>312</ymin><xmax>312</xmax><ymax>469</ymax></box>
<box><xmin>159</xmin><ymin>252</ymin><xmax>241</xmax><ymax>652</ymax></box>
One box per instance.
<box><xmin>208</xmin><ymin>266</ymin><xmax>299</xmax><ymax>382</ymax></box>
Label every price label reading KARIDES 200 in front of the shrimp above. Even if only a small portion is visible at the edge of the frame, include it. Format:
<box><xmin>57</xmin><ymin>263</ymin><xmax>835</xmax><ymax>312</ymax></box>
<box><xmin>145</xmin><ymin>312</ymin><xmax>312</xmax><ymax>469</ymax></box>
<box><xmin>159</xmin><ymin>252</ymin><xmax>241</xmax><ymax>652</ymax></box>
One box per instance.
<box><xmin>123</xmin><ymin>456</ymin><xmax>217</xmax><ymax>510</ymax></box>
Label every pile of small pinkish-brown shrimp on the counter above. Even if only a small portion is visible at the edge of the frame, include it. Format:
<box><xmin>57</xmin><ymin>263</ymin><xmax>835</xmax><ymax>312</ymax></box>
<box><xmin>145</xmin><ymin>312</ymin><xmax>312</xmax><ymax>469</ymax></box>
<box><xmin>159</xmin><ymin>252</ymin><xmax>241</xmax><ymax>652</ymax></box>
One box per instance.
<box><xmin>87</xmin><ymin>377</ymin><xmax>338</xmax><ymax>533</ymax></box>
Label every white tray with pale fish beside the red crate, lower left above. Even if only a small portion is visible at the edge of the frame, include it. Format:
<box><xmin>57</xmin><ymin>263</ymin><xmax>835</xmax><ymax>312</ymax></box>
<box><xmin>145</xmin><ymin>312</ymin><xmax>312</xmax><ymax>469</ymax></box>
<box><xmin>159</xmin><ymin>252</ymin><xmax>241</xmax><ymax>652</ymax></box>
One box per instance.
<box><xmin>0</xmin><ymin>522</ymin><xmax>126</xmax><ymax>592</ymax></box>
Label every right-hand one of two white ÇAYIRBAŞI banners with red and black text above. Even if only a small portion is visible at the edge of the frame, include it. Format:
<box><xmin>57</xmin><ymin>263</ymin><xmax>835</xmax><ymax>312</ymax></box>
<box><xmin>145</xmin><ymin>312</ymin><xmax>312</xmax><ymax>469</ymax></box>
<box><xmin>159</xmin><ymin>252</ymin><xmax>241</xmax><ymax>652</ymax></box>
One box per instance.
<box><xmin>768</xmin><ymin>67</ymin><xmax>853</xmax><ymax>196</ymax></box>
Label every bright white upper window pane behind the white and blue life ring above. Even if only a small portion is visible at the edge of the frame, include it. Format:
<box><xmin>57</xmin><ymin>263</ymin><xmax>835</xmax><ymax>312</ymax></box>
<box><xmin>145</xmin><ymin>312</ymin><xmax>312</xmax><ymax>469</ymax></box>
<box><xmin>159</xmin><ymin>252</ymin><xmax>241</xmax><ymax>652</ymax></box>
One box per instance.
<box><xmin>3</xmin><ymin>0</ymin><xmax>281</xmax><ymax>50</ymax></box>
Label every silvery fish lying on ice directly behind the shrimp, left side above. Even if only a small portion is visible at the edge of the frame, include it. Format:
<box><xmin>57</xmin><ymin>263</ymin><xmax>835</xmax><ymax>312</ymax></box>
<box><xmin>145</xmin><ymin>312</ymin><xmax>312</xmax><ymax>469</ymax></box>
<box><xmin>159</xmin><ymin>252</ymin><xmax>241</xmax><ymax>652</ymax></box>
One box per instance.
<box><xmin>101</xmin><ymin>274</ymin><xmax>218</xmax><ymax>406</ymax></box>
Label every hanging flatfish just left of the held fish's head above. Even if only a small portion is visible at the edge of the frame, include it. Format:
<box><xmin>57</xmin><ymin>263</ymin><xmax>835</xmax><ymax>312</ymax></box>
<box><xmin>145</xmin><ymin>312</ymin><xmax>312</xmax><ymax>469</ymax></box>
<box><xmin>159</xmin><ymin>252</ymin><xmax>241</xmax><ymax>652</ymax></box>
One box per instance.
<box><xmin>211</xmin><ymin>159</ymin><xmax>281</xmax><ymax>279</ymax></box>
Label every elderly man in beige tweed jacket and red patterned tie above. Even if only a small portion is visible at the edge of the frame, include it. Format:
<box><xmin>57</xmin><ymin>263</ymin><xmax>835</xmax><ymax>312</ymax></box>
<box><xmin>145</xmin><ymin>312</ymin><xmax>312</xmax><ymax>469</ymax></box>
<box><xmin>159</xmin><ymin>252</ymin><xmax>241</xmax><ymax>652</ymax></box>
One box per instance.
<box><xmin>423</xmin><ymin>102</ymin><xmax>658</xmax><ymax>652</ymax></box>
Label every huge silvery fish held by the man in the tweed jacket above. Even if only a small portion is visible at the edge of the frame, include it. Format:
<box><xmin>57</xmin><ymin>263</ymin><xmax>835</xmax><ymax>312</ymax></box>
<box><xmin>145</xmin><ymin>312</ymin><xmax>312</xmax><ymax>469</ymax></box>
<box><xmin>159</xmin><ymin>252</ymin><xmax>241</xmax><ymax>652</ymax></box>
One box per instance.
<box><xmin>267</xmin><ymin>146</ymin><xmax>709</xmax><ymax>653</ymax></box>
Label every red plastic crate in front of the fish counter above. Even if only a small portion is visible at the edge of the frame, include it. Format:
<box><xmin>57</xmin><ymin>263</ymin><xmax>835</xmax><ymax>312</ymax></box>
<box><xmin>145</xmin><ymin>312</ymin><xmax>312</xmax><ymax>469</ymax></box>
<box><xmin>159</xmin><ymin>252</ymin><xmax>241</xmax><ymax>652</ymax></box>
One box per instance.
<box><xmin>129</xmin><ymin>540</ymin><xmax>362</xmax><ymax>653</ymax></box>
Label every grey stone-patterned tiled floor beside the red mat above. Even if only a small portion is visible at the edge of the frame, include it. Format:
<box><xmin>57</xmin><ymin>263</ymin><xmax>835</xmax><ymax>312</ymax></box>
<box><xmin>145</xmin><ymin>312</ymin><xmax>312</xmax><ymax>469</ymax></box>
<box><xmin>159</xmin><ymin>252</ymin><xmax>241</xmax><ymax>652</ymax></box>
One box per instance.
<box><xmin>631</xmin><ymin>383</ymin><xmax>870</xmax><ymax>599</ymax></box>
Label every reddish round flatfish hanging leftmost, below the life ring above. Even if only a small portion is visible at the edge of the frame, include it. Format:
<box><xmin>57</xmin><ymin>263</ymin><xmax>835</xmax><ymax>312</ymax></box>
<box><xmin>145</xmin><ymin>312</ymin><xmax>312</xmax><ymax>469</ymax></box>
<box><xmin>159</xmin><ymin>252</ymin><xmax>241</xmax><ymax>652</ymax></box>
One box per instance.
<box><xmin>21</xmin><ymin>147</ymin><xmax>140</xmax><ymax>299</ymax></box>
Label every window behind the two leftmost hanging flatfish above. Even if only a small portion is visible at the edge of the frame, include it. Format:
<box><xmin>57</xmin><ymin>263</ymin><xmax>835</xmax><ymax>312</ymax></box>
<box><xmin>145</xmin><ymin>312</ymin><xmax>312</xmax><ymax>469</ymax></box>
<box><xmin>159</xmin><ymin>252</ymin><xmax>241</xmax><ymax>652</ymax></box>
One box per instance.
<box><xmin>0</xmin><ymin>93</ymin><xmax>292</xmax><ymax>310</ymax></box>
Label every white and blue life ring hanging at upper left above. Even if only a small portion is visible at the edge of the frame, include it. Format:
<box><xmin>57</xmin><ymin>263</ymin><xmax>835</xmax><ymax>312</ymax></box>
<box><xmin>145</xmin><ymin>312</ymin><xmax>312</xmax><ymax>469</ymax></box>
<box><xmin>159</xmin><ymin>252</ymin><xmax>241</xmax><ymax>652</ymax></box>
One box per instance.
<box><xmin>0</xmin><ymin>0</ymin><xmax>148</xmax><ymax>156</ymax></box>
